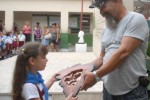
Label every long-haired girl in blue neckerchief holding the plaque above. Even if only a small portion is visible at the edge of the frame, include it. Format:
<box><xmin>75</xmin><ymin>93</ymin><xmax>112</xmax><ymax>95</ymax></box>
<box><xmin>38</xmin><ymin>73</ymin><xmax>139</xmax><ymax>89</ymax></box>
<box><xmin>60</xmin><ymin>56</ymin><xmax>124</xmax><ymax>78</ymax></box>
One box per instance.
<box><xmin>12</xmin><ymin>42</ymin><xmax>76</xmax><ymax>100</ymax></box>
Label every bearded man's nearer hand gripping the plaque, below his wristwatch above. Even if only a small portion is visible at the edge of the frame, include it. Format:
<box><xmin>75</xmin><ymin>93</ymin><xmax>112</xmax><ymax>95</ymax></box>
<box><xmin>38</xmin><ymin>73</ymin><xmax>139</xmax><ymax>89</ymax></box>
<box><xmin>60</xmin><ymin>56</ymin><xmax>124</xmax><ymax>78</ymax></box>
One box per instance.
<box><xmin>81</xmin><ymin>72</ymin><xmax>96</xmax><ymax>90</ymax></box>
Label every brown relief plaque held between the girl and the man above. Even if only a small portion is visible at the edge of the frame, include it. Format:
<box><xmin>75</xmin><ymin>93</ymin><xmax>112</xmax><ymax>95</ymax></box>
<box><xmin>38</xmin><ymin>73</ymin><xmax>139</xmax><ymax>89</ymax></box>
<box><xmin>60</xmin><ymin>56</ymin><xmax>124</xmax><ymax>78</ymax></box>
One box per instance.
<box><xmin>57</xmin><ymin>63</ymin><xmax>93</xmax><ymax>97</ymax></box>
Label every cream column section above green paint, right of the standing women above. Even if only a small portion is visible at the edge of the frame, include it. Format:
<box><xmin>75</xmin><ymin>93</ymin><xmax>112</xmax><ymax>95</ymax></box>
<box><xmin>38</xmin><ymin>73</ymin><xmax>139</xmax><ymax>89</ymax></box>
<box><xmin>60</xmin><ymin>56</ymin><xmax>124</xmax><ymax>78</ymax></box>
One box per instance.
<box><xmin>61</xmin><ymin>11</ymin><xmax>69</xmax><ymax>33</ymax></box>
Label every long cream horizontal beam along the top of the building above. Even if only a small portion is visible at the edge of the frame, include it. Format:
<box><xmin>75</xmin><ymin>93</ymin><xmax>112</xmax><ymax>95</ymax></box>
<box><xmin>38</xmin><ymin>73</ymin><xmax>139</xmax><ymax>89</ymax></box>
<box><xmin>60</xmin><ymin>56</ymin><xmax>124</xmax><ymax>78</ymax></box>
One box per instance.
<box><xmin>0</xmin><ymin>0</ymin><xmax>92</xmax><ymax>12</ymax></box>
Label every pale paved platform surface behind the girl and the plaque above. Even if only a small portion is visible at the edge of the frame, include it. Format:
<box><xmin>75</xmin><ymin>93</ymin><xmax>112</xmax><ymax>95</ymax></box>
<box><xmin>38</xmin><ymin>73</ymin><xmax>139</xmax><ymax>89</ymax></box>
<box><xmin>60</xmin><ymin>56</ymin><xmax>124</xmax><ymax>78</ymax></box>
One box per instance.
<box><xmin>0</xmin><ymin>52</ymin><xmax>102</xmax><ymax>93</ymax></box>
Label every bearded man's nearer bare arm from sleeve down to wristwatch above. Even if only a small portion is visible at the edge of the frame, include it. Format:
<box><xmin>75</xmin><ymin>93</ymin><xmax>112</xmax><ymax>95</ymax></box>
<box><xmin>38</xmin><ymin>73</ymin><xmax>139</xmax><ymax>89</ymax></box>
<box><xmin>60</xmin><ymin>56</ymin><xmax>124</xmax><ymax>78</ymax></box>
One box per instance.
<box><xmin>96</xmin><ymin>36</ymin><xmax>142</xmax><ymax>77</ymax></box>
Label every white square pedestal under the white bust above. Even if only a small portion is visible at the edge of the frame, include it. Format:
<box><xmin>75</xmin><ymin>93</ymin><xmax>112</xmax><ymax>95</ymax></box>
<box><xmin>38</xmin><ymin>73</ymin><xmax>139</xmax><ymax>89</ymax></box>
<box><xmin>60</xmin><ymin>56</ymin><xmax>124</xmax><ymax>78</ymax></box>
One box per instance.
<box><xmin>75</xmin><ymin>43</ymin><xmax>87</xmax><ymax>52</ymax></box>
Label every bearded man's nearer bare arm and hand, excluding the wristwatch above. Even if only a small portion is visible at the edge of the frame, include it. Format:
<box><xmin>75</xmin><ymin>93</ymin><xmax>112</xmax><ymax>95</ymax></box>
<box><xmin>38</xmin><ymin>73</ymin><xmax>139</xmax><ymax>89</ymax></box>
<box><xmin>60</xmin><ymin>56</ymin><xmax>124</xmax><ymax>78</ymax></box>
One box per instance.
<box><xmin>81</xmin><ymin>37</ymin><xmax>142</xmax><ymax>90</ymax></box>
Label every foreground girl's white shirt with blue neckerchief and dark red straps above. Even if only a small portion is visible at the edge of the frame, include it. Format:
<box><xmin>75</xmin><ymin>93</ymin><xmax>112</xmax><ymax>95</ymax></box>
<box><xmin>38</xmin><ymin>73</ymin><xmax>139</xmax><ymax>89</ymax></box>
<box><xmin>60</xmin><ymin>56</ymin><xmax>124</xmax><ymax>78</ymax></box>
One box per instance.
<box><xmin>22</xmin><ymin>72</ymin><xmax>52</xmax><ymax>100</ymax></box>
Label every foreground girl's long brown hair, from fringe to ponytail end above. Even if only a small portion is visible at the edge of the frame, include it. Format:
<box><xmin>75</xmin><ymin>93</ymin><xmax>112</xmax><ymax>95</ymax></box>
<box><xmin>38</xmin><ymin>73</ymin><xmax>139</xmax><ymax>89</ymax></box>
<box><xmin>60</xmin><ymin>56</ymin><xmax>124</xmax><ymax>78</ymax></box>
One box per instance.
<box><xmin>12</xmin><ymin>42</ymin><xmax>48</xmax><ymax>100</ymax></box>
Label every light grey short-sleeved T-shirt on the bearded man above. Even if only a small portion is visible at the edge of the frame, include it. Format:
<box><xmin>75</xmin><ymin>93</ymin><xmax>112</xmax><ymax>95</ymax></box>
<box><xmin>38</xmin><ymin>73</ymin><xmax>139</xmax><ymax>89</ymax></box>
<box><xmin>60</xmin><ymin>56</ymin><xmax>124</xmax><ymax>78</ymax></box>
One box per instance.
<box><xmin>102</xmin><ymin>12</ymin><xmax>149</xmax><ymax>95</ymax></box>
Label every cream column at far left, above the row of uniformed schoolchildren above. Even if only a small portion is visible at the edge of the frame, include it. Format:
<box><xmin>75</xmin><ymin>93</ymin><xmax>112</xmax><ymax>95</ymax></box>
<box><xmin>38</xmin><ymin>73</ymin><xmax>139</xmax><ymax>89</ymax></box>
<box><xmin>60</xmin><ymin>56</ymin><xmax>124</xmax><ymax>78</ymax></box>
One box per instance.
<box><xmin>5</xmin><ymin>11</ymin><xmax>14</xmax><ymax>31</ymax></box>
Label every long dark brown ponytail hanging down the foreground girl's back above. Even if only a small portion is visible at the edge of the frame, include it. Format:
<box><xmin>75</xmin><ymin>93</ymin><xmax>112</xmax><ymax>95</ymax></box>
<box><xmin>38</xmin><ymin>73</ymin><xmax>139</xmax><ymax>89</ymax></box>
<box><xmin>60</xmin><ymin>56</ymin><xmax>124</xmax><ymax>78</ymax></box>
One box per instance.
<box><xmin>12</xmin><ymin>52</ymin><xmax>28</xmax><ymax>100</ymax></box>
